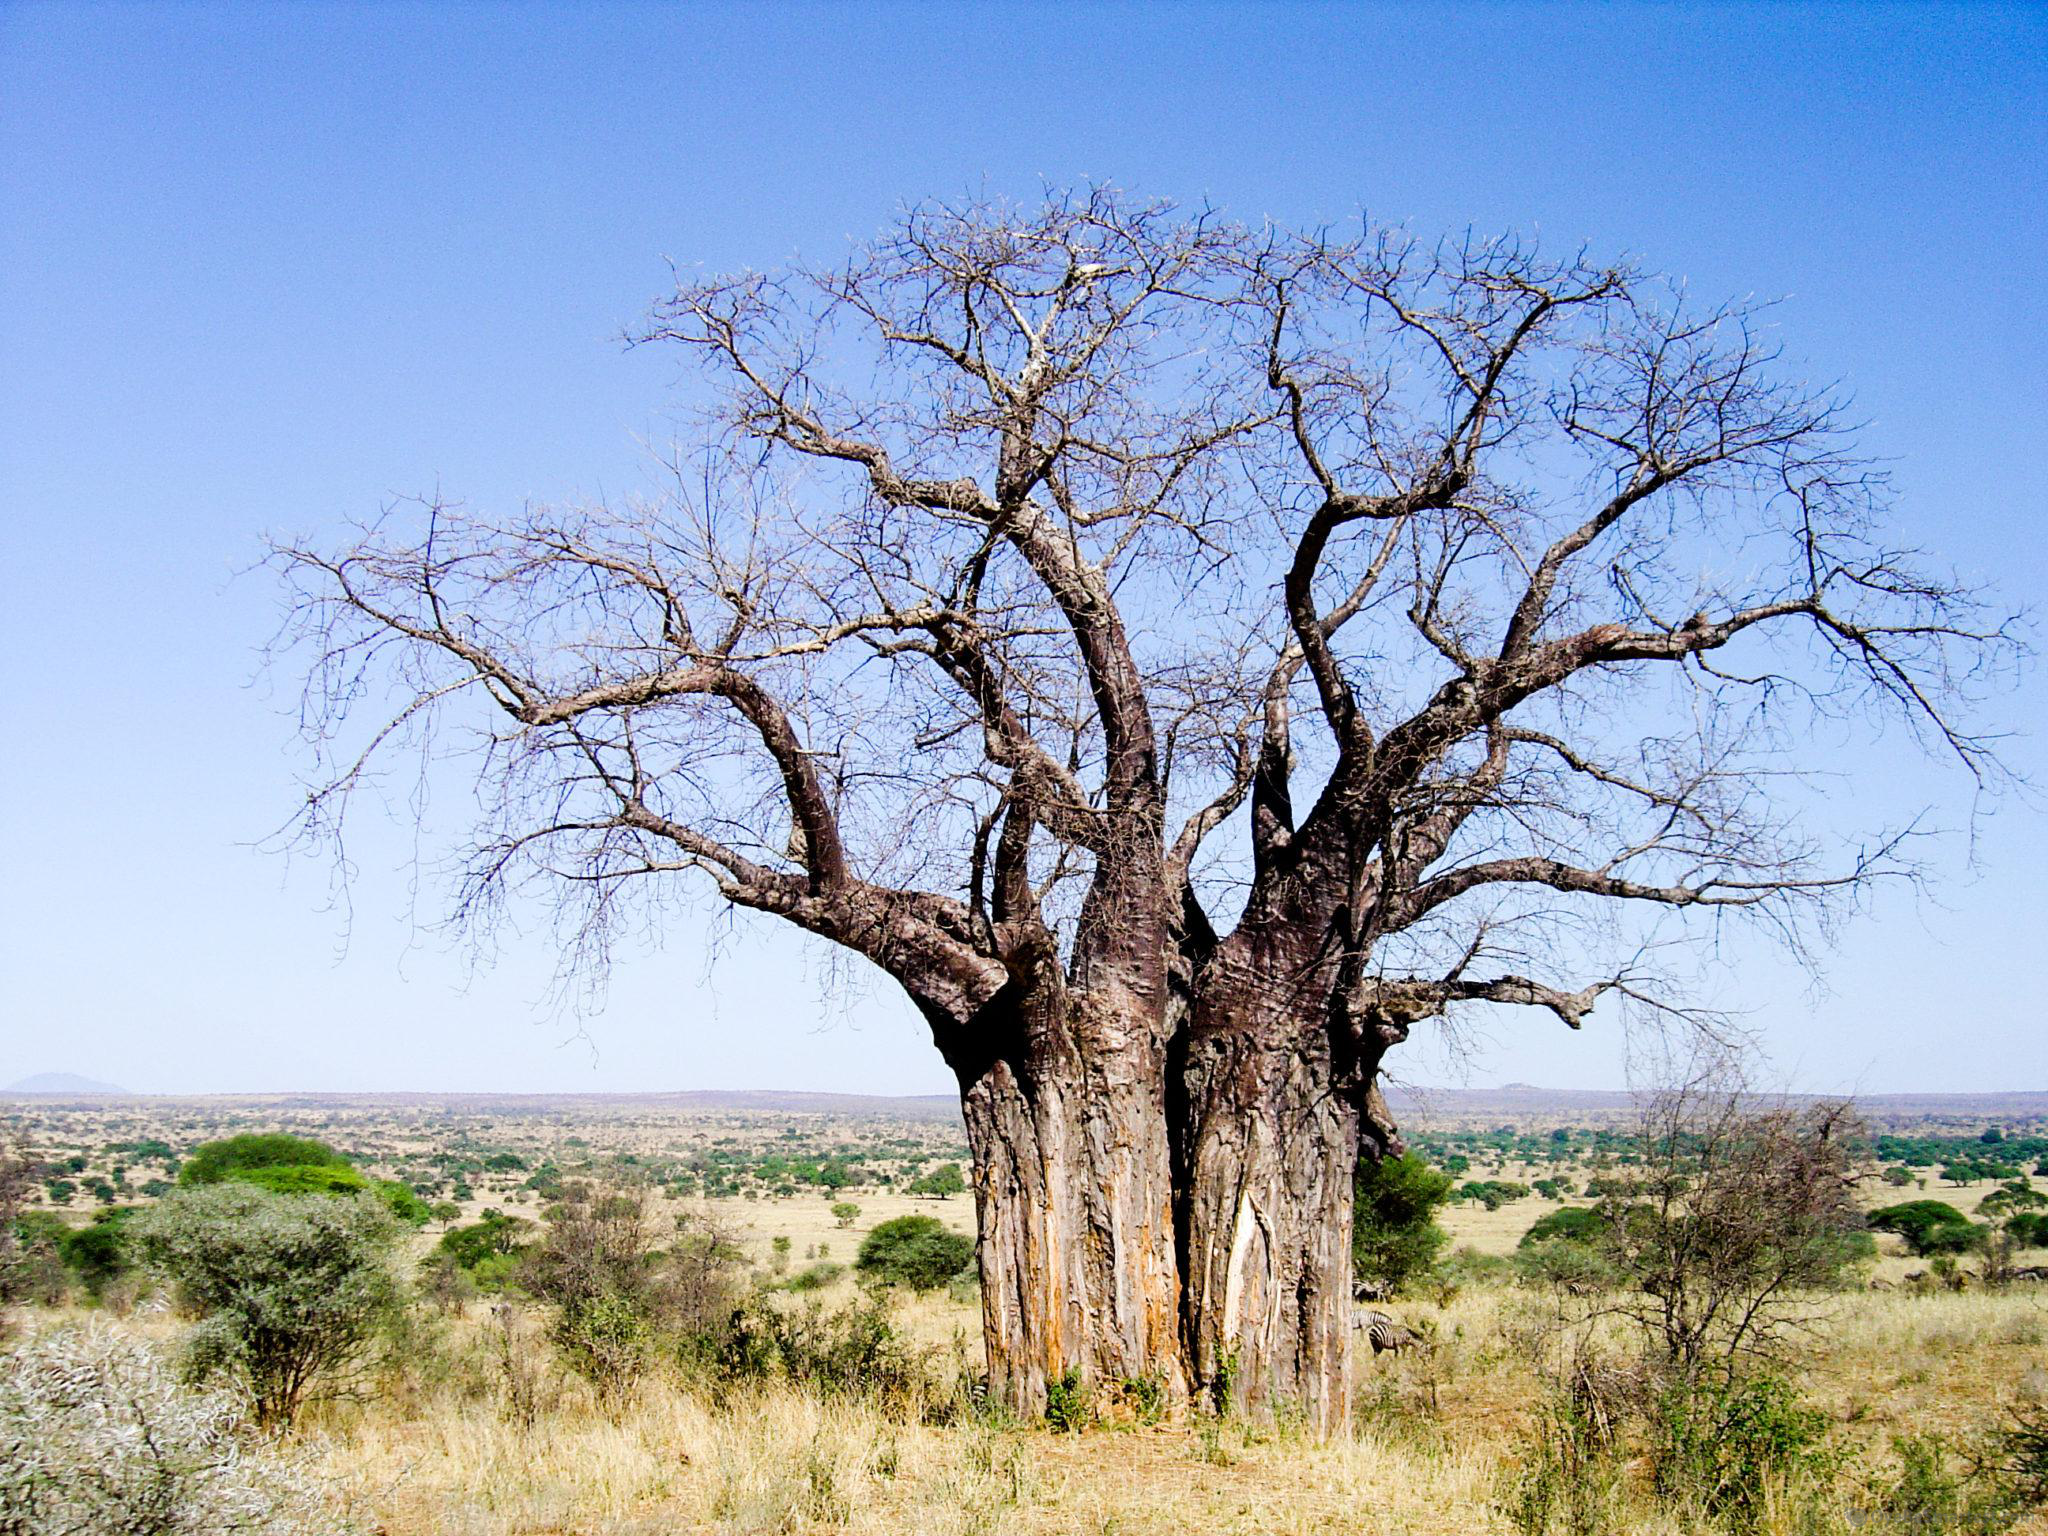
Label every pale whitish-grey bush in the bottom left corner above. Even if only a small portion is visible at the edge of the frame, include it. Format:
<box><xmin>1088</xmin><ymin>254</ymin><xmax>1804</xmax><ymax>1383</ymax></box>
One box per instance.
<box><xmin>0</xmin><ymin>1327</ymin><xmax>344</xmax><ymax>1536</ymax></box>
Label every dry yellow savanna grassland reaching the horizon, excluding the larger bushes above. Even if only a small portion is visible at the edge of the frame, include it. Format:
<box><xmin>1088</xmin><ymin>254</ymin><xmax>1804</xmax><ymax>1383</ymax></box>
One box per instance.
<box><xmin>8</xmin><ymin>1096</ymin><xmax>2048</xmax><ymax>1536</ymax></box>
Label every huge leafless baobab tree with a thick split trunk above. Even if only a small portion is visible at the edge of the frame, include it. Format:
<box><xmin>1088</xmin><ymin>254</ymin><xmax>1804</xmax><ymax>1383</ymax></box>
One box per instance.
<box><xmin>264</xmin><ymin>188</ymin><xmax>1999</xmax><ymax>1423</ymax></box>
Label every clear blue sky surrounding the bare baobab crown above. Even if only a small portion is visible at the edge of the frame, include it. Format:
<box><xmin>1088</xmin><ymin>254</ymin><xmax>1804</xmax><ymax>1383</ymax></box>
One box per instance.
<box><xmin>0</xmin><ymin>4</ymin><xmax>2048</xmax><ymax>1092</ymax></box>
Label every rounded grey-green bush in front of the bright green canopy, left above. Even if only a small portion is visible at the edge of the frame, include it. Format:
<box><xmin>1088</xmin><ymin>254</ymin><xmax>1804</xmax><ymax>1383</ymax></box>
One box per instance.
<box><xmin>131</xmin><ymin>1184</ymin><xmax>397</xmax><ymax>1427</ymax></box>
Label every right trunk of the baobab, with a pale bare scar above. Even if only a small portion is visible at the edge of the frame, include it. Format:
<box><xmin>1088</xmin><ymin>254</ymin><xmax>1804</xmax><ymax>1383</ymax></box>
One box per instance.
<box><xmin>1176</xmin><ymin>1010</ymin><xmax>1360</xmax><ymax>1434</ymax></box>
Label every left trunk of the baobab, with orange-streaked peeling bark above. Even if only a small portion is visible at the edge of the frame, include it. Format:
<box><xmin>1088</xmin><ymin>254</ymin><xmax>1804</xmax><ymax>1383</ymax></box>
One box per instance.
<box><xmin>952</xmin><ymin>983</ymin><xmax>1188</xmax><ymax>1415</ymax></box>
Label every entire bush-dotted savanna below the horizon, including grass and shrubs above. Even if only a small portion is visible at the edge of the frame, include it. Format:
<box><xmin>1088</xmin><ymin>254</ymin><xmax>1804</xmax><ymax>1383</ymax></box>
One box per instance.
<box><xmin>0</xmin><ymin>1083</ymin><xmax>2048</xmax><ymax>1536</ymax></box>
